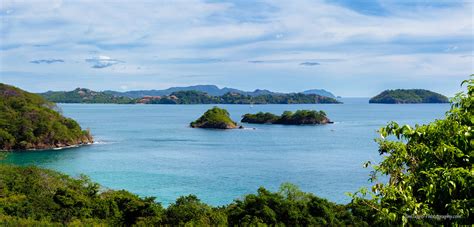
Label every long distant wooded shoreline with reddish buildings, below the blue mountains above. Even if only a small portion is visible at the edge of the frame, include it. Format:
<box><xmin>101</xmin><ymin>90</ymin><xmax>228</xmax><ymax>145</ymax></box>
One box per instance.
<box><xmin>40</xmin><ymin>88</ymin><xmax>340</xmax><ymax>104</ymax></box>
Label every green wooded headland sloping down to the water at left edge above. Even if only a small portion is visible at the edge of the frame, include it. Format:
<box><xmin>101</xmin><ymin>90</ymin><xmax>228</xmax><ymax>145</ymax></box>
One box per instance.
<box><xmin>0</xmin><ymin>83</ymin><xmax>92</xmax><ymax>150</ymax></box>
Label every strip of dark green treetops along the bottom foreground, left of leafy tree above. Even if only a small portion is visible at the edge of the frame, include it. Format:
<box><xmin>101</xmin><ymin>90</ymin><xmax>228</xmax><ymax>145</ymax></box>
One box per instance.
<box><xmin>0</xmin><ymin>164</ymin><xmax>365</xmax><ymax>226</ymax></box>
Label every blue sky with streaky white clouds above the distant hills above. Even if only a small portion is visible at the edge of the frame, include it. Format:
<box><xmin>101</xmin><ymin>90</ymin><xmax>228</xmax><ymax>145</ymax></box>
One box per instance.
<box><xmin>0</xmin><ymin>0</ymin><xmax>474</xmax><ymax>97</ymax></box>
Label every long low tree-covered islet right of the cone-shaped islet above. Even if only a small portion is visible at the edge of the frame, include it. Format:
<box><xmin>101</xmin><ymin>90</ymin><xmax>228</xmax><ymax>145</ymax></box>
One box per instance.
<box><xmin>241</xmin><ymin>110</ymin><xmax>333</xmax><ymax>125</ymax></box>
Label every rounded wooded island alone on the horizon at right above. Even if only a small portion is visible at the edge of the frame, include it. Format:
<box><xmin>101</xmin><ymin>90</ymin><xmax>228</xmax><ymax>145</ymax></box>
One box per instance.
<box><xmin>369</xmin><ymin>89</ymin><xmax>449</xmax><ymax>104</ymax></box>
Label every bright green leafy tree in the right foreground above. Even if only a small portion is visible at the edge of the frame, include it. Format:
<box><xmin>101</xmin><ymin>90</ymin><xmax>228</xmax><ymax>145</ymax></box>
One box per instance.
<box><xmin>354</xmin><ymin>76</ymin><xmax>474</xmax><ymax>224</ymax></box>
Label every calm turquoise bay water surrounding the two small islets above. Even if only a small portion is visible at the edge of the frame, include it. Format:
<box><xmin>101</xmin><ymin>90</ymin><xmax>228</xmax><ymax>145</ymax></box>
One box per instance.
<box><xmin>2</xmin><ymin>99</ymin><xmax>449</xmax><ymax>205</ymax></box>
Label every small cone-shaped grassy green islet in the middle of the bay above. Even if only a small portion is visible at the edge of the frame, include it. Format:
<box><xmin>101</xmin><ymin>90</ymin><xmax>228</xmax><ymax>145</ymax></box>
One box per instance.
<box><xmin>190</xmin><ymin>106</ymin><xmax>238</xmax><ymax>129</ymax></box>
